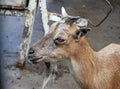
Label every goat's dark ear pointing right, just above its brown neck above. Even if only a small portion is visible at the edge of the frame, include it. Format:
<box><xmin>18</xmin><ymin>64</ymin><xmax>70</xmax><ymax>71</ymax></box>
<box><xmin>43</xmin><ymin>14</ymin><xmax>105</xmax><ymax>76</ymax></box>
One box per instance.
<box><xmin>73</xmin><ymin>28</ymin><xmax>91</xmax><ymax>41</ymax></box>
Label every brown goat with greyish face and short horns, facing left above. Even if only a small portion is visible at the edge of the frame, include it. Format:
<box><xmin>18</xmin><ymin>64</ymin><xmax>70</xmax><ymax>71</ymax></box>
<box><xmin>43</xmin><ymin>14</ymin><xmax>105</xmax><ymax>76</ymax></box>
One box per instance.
<box><xmin>29</xmin><ymin>7</ymin><xmax>120</xmax><ymax>89</ymax></box>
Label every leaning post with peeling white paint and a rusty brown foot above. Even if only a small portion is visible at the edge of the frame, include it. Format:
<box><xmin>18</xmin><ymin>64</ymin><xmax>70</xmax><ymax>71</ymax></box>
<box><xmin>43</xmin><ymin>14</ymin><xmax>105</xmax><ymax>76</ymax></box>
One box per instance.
<box><xmin>16</xmin><ymin>0</ymin><xmax>38</xmax><ymax>68</ymax></box>
